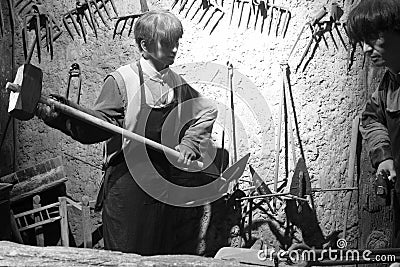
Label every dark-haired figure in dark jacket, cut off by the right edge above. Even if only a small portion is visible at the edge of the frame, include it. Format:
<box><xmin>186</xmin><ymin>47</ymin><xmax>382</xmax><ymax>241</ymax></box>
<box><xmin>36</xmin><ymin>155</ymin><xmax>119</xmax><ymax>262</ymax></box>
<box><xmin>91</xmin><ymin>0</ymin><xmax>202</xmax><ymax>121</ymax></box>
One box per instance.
<box><xmin>348</xmin><ymin>0</ymin><xmax>400</xmax><ymax>247</ymax></box>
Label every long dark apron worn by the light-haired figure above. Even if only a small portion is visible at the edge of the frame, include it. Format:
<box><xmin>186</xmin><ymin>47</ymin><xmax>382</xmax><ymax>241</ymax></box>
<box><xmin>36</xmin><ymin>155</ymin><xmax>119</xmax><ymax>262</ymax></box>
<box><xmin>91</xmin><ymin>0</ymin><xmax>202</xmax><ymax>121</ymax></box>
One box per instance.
<box><xmin>102</xmin><ymin>61</ymin><xmax>177</xmax><ymax>255</ymax></box>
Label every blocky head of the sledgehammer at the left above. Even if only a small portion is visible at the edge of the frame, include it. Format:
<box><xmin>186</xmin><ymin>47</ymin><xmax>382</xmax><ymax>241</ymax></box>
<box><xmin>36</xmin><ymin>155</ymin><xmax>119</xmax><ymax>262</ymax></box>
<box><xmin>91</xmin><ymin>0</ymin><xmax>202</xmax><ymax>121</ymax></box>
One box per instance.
<box><xmin>8</xmin><ymin>64</ymin><xmax>43</xmax><ymax>121</ymax></box>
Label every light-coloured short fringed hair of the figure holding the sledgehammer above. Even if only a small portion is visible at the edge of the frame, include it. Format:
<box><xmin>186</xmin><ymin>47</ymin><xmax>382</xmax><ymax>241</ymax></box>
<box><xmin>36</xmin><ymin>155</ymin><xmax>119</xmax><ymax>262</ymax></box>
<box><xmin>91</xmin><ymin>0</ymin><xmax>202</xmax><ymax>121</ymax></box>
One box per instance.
<box><xmin>133</xmin><ymin>10</ymin><xmax>183</xmax><ymax>51</ymax></box>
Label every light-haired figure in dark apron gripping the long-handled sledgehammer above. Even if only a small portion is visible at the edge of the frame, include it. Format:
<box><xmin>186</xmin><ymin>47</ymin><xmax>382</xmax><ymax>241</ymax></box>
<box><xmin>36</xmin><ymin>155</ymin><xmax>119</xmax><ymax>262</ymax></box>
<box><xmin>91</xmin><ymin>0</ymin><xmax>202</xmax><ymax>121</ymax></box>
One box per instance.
<box><xmin>37</xmin><ymin>11</ymin><xmax>217</xmax><ymax>255</ymax></box>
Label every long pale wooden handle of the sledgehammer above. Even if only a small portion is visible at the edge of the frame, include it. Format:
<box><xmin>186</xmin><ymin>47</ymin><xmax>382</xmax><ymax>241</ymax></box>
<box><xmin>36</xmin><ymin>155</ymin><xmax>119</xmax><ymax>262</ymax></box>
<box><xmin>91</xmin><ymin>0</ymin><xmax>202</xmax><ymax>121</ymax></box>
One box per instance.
<box><xmin>39</xmin><ymin>96</ymin><xmax>204</xmax><ymax>170</ymax></box>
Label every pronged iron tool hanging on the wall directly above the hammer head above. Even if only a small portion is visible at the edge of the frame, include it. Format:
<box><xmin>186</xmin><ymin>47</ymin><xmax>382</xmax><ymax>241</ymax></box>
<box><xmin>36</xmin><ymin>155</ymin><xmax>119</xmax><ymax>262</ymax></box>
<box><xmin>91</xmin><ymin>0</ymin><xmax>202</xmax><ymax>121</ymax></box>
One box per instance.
<box><xmin>22</xmin><ymin>0</ymin><xmax>62</xmax><ymax>63</ymax></box>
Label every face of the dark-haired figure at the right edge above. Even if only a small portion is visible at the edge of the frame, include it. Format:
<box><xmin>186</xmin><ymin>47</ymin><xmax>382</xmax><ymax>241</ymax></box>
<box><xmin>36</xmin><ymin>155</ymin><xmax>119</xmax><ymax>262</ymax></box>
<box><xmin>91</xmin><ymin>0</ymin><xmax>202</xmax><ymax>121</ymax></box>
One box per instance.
<box><xmin>363</xmin><ymin>31</ymin><xmax>400</xmax><ymax>73</ymax></box>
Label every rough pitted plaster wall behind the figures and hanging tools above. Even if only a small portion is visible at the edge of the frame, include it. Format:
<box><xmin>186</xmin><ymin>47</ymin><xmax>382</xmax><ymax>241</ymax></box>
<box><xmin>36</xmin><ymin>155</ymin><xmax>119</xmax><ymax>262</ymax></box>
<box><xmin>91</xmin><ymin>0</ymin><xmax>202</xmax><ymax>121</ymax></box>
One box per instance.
<box><xmin>6</xmin><ymin>0</ymin><xmax>386</xmax><ymax>251</ymax></box>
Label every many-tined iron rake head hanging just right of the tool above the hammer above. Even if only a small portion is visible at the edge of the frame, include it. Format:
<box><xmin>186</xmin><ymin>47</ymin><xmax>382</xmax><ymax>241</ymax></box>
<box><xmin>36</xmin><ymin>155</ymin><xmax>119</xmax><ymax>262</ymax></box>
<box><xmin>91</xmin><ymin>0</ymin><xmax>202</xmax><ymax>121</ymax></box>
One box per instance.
<box><xmin>63</xmin><ymin>0</ymin><xmax>118</xmax><ymax>42</ymax></box>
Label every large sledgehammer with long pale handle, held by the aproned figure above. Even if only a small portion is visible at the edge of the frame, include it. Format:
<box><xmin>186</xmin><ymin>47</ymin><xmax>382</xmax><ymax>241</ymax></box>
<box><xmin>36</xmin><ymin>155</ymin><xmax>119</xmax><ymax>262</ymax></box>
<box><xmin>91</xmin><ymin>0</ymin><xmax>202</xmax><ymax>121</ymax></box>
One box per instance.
<box><xmin>6</xmin><ymin>64</ymin><xmax>209</xmax><ymax>174</ymax></box>
